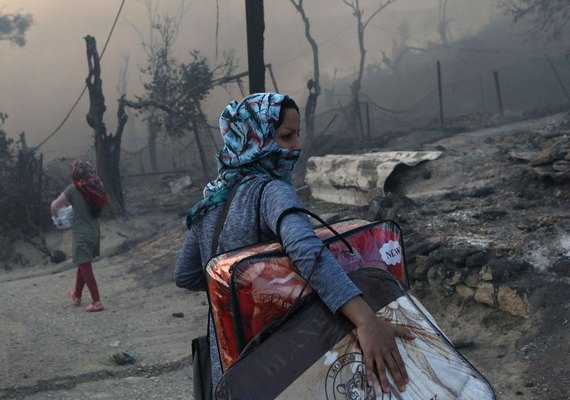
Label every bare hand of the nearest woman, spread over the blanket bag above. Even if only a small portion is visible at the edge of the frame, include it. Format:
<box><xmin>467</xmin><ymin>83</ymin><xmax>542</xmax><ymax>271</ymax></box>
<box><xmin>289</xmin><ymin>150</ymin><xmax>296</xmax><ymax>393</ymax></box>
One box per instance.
<box><xmin>341</xmin><ymin>297</ymin><xmax>415</xmax><ymax>393</ymax></box>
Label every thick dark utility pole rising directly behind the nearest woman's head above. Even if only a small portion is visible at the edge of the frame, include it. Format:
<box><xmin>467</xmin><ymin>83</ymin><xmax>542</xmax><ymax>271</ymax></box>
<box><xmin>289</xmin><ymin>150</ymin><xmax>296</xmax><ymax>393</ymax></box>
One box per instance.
<box><xmin>245</xmin><ymin>0</ymin><xmax>265</xmax><ymax>93</ymax></box>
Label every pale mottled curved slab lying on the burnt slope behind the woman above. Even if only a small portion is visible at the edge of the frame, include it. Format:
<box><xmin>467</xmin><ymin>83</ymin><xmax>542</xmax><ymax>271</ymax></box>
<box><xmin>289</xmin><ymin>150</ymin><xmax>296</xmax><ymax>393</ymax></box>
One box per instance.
<box><xmin>305</xmin><ymin>151</ymin><xmax>441</xmax><ymax>206</ymax></box>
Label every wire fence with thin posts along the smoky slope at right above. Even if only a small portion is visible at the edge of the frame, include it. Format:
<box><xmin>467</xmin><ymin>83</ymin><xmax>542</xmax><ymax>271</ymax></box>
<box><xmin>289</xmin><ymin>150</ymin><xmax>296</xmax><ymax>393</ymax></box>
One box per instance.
<box><xmin>308</xmin><ymin>52</ymin><xmax>570</xmax><ymax>137</ymax></box>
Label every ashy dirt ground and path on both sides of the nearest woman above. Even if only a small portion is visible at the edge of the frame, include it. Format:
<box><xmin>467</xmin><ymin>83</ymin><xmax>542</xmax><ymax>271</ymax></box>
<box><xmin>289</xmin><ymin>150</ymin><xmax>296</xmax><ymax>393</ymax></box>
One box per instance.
<box><xmin>0</xmin><ymin>116</ymin><xmax>570</xmax><ymax>400</ymax></box>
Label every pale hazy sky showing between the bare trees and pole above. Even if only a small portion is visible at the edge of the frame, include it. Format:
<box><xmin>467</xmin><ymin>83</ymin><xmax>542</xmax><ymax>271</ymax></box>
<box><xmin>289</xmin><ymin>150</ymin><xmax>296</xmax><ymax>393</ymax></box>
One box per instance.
<box><xmin>0</xmin><ymin>0</ymin><xmax>494</xmax><ymax>158</ymax></box>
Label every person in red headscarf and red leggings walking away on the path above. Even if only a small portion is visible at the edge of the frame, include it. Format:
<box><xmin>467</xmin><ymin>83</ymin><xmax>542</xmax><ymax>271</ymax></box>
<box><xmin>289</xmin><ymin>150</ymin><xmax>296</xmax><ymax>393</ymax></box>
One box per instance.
<box><xmin>51</xmin><ymin>160</ymin><xmax>107</xmax><ymax>312</ymax></box>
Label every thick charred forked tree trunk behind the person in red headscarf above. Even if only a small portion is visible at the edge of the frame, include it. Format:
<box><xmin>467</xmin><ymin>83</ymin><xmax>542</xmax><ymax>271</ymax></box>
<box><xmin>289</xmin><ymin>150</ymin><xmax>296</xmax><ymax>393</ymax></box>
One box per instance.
<box><xmin>85</xmin><ymin>35</ymin><xmax>127</xmax><ymax>216</ymax></box>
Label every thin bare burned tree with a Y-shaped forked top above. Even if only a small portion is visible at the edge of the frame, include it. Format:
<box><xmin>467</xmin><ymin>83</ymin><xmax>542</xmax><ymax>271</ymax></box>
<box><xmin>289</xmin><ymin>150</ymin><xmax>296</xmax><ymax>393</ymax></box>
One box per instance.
<box><xmin>342</xmin><ymin>0</ymin><xmax>396</xmax><ymax>135</ymax></box>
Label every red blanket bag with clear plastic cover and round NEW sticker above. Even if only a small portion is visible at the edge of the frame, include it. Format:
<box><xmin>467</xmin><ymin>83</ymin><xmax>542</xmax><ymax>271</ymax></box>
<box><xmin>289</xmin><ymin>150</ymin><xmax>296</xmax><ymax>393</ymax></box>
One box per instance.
<box><xmin>206</xmin><ymin>220</ymin><xmax>408</xmax><ymax>372</ymax></box>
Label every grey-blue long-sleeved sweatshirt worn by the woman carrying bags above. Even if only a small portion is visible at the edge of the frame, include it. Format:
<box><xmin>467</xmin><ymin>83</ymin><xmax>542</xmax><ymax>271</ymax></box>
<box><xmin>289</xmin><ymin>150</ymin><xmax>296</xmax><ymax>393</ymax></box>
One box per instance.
<box><xmin>174</xmin><ymin>178</ymin><xmax>361</xmax><ymax>388</ymax></box>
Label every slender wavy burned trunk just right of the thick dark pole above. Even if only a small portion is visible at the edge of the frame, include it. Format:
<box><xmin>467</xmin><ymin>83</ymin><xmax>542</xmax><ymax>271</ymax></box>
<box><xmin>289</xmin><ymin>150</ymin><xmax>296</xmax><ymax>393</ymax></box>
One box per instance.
<box><xmin>290</xmin><ymin>0</ymin><xmax>321</xmax><ymax>140</ymax></box>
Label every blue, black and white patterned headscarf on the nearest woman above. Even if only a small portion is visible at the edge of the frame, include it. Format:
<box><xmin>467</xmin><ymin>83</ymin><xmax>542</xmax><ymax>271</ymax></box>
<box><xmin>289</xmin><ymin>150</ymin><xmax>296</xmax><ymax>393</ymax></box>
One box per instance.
<box><xmin>186</xmin><ymin>93</ymin><xmax>300</xmax><ymax>229</ymax></box>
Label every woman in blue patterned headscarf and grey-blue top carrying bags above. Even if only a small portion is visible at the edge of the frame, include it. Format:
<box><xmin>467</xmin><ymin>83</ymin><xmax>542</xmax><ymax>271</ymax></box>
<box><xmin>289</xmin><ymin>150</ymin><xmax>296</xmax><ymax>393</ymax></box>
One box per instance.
<box><xmin>175</xmin><ymin>93</ymin><xmax>413</xmax><ymax>392</ymax></box>
